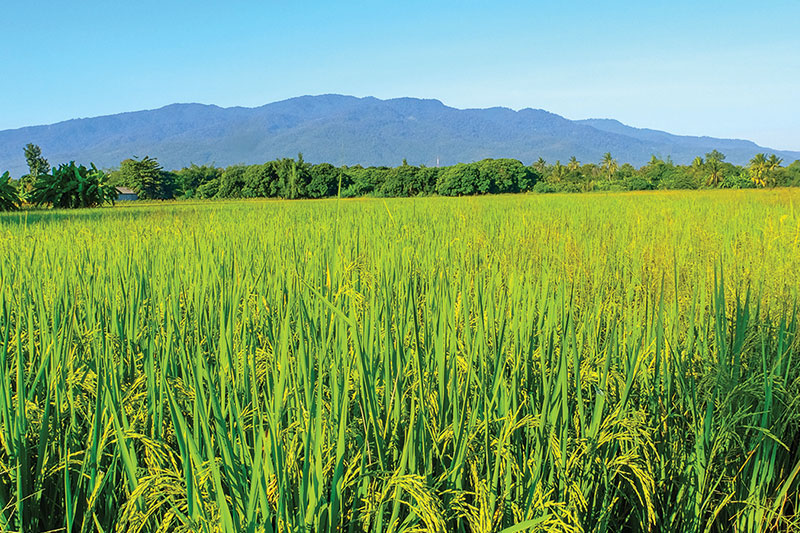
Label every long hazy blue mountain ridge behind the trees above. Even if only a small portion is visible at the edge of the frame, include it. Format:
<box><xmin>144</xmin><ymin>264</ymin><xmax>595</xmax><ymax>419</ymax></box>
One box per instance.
<box><xmin>0</xmin><ymin>95</ymin><xmax>800</xmax><ymax>176</ymax></box>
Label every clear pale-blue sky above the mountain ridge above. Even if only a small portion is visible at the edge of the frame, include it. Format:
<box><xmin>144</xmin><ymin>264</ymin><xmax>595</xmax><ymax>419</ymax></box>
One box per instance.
<box><xmin>0</xmin><ymin>0</ymin><xmax>800</xmax><ymax>150</ymax></box>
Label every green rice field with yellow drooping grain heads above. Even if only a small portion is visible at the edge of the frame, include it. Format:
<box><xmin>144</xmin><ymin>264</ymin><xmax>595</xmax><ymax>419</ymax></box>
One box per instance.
<box><xmin>0</xmin><ymin>189</ymin><xmax>800</xmax><ymax>533</ymax></box>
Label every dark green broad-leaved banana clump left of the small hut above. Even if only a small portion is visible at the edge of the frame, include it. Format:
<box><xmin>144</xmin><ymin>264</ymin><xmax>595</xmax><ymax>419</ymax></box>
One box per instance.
<box><xmin>29</xmin><ymin>161</ymin><xmax>117</xmax><ymax>209</ymax></box>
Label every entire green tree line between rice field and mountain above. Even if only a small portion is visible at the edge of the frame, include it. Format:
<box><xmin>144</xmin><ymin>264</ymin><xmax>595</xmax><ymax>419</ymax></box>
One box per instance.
<box><xmin>0</xmin><ymin>144</ymin><xmax>800</xmax><ymax>209</ymax></box>
